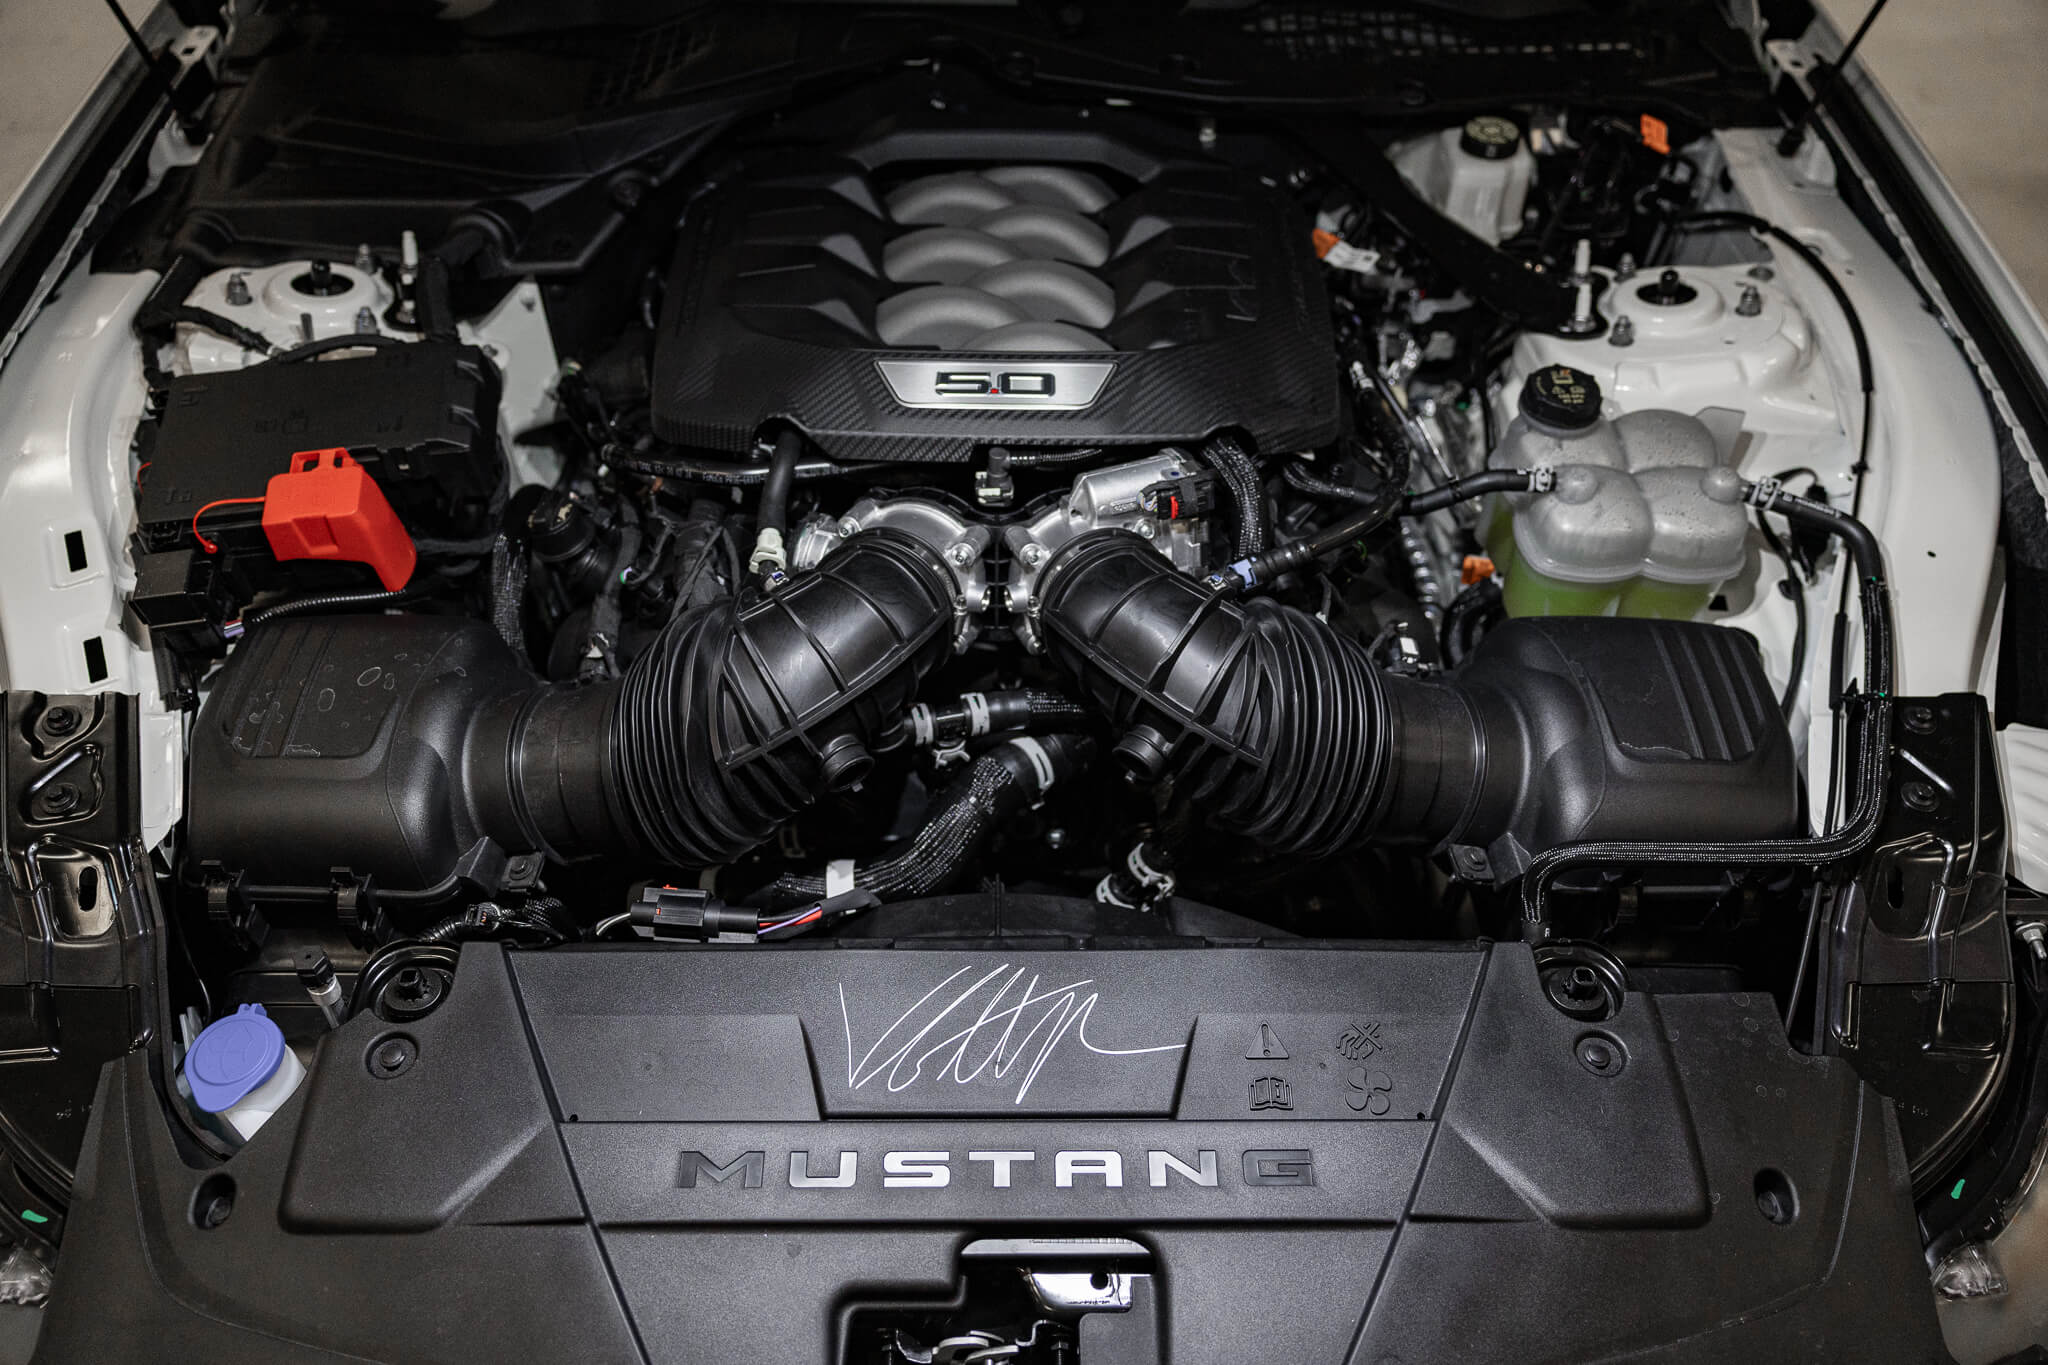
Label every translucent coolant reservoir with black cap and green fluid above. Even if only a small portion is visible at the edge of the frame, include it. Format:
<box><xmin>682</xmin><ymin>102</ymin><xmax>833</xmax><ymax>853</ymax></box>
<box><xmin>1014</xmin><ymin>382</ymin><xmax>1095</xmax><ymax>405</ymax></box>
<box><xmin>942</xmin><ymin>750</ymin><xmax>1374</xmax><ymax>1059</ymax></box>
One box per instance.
<box><xmin>1483</xmin><ymin>364</ymin><xmax>1749</xmax><ymax>620</ymax></box>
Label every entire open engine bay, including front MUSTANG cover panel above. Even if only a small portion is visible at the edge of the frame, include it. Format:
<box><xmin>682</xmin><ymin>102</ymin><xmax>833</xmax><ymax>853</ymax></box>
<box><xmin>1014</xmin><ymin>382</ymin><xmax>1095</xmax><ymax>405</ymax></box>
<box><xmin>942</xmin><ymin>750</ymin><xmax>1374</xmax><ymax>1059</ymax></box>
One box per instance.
<box><xmin>0</xmin><ymin>6</ymin><xmax>2038</xmax><ymax>1365</ymax></box>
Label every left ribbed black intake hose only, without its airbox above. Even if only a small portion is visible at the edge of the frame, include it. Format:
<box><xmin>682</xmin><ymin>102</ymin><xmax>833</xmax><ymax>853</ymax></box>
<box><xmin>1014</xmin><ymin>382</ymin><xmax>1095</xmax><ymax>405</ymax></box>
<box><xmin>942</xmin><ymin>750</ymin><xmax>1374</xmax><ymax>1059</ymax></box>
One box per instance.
<box><xmin>479</xmin><ymin>530</ymin><xmax>952</xmax><ymax>868</ymax></box>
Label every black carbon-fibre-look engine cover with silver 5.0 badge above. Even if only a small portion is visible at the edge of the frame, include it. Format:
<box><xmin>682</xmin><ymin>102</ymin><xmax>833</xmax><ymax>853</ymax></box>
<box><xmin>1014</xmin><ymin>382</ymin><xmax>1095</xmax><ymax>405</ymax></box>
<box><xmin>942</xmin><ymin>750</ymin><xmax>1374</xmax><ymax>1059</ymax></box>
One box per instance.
<box><xmin>653</xmin><ymin>129</ymin><xmax>1339</xmax><ymax>460</ymax></box>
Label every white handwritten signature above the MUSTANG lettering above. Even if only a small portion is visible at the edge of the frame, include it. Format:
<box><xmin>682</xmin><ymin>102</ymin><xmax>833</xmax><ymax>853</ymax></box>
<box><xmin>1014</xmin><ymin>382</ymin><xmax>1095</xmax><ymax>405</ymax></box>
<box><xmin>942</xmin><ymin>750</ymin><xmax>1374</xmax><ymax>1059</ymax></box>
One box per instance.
<box><xmin>840</xmin><ymin>962</ymin><xmax>1188</xmax><ymax>1103</ymax></box>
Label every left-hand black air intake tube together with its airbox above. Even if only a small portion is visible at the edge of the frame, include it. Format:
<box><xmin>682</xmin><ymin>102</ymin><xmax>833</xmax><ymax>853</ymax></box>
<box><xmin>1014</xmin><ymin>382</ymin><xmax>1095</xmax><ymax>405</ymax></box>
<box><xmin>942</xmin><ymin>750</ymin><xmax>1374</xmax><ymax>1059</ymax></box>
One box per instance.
<box><xmin>186</xmin><ymin>530</ymin><xmax>954</xmax><ymax>902</ymax></box>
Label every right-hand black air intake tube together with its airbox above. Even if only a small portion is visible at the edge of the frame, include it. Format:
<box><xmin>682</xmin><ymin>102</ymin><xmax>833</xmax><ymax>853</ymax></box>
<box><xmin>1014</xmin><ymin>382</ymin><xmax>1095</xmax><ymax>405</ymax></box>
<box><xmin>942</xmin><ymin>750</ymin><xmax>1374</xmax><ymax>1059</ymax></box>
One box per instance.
<box><xmin>1036</xmin><ymin>530</ymin><xmax>1798</xmax><ymax>880</ymax></box>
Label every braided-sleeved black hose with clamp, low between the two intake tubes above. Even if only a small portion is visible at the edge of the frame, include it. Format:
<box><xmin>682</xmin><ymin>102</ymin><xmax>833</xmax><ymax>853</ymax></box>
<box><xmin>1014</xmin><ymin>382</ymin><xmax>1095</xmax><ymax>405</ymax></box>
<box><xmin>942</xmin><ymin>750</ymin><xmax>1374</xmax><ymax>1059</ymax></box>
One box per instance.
<box><xmin>768</xmin><ymin>735</ymin><xmax>1096</xmax><ymax>907</ymax></box>
